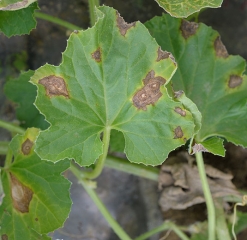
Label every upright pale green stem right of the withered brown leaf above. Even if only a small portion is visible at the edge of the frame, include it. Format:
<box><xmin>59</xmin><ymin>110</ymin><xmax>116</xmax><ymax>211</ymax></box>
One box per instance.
<box><xmin>195</xmin><ymin>152</ymin><xmax>215</xmax><ymax>240</ymax></box>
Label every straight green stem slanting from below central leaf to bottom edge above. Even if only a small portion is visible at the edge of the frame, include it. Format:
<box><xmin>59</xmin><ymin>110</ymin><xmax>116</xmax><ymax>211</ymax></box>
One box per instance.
<box><xmin>70</xmin><ymin>164</ymin><xmax>131</xmax><ymax>240</ymax></box>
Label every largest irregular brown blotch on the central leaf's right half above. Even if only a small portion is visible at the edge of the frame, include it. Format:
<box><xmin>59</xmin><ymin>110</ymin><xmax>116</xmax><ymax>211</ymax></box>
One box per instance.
<box><xmin>132</xmin><ymin>70</ymin><xmax>166</xmax><ymax>110</ymax></box>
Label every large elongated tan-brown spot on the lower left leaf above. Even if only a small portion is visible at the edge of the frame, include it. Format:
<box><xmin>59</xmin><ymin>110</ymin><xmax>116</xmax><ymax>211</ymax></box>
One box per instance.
<box><xmin>10</xmin><ymin>174</ymin><xmax>33</xmax><ymax>213</ymax></box>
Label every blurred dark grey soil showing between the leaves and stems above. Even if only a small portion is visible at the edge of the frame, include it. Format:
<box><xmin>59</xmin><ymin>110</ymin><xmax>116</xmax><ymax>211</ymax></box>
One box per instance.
<box><xmin>0</xmin><ymin>0</ymin><xmax>247</xmax><ymax>240</ymax></box>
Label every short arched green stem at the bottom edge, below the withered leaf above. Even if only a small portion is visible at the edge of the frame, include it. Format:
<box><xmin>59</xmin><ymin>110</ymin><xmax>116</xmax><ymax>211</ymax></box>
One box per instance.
<box><xmin>135</xmin><ymin>222</ymin><xmax>189</xmax><ymax>240</ymax></box>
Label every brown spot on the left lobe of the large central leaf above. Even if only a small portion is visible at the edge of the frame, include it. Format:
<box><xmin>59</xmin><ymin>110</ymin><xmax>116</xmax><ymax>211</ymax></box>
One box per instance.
<box><xmin>39</xmin><ymin>75</ymin><xmax>69</xmax><ymax>98</ymax></box>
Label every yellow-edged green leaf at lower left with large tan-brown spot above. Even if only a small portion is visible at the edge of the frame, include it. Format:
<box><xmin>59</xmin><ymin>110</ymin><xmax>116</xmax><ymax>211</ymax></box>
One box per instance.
<box><xmin>0</xmin><ymin>128</ymin><xmax>71</xmax><ymax>240</ymax></box>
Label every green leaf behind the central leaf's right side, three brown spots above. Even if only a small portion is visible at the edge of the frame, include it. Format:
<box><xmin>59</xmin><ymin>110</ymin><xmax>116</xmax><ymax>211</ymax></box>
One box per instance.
<box><xmin>146</xmin><ymin>14</ymin><xmax>247</xmax><ymax>154</ymax></box>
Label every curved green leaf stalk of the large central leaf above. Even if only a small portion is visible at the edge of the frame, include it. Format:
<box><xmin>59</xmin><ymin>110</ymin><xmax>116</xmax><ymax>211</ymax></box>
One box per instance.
<box><xmin>83</xmin><ymin>127</ymin><xmax>111</xmax><ymax>179</ymax></box>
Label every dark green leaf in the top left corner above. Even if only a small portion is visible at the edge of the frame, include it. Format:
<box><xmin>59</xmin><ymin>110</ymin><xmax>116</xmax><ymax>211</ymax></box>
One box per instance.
<box><xmin>0</xmin><ymin>2</ymin><xmax>38</xmax><ymax>37</ymax></box>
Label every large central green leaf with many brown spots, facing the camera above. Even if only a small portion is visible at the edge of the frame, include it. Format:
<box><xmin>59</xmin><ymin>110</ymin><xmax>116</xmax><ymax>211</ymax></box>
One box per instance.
<box><xmin>32</xmin><ymin>6</ymin><xmax>197</xmax><ymax>166</ymax></box>
